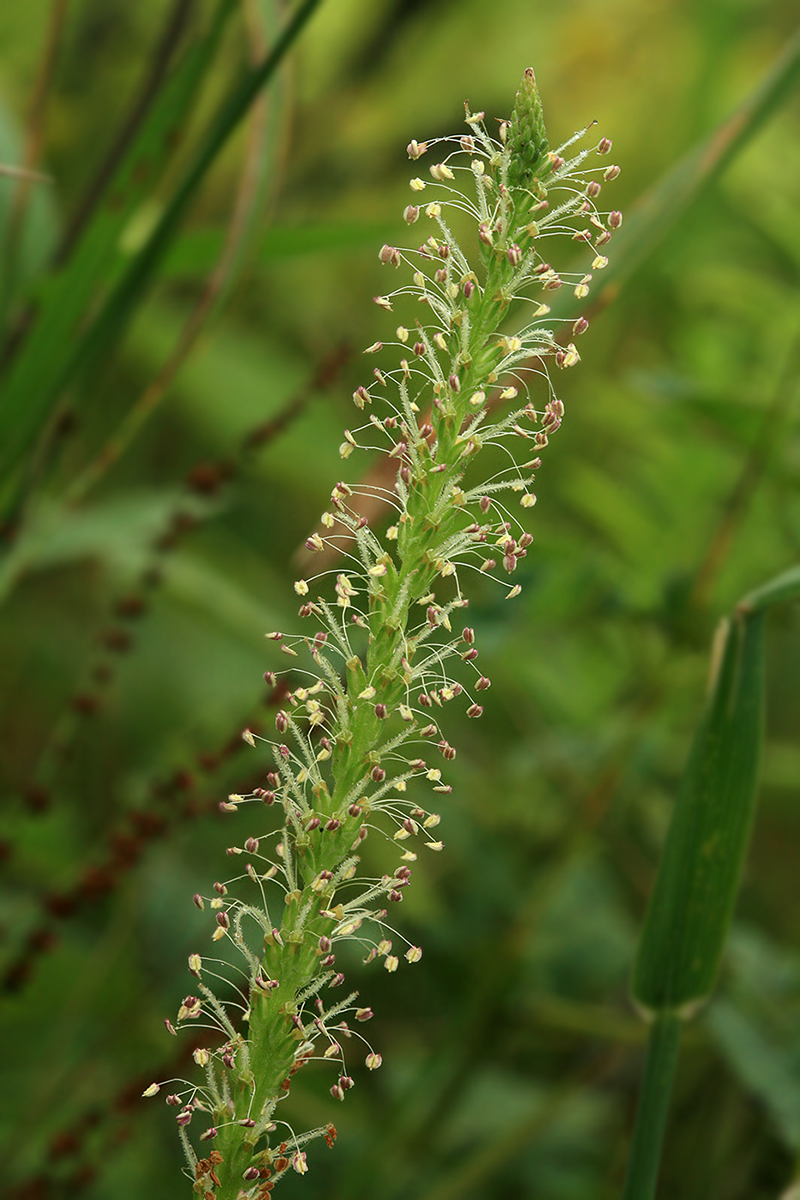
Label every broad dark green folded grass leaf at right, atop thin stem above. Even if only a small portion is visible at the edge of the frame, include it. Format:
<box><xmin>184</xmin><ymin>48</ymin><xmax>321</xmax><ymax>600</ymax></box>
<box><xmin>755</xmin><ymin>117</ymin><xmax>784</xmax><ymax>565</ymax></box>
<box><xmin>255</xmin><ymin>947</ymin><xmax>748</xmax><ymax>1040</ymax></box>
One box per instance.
<box><xmin>632</xmin><ymin>612</ymin><xmax>765</xmax><ymax>1016</ymax></box>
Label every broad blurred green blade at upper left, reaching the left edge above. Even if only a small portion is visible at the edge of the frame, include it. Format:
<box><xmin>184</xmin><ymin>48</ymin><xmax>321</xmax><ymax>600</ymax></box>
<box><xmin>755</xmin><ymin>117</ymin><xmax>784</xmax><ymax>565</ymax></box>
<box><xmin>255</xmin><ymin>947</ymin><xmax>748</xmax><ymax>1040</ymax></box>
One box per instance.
<box><xmin>0</xmin><ymin>0</ymin><xmax>236</xmax><ymax>492</ymax></box>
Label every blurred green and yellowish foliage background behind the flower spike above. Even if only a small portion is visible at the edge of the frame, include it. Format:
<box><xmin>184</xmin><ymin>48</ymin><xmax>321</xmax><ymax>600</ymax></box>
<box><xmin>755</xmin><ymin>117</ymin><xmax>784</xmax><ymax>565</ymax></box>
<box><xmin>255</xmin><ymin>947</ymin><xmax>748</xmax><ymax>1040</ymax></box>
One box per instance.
<box><xmin>0</xmin><ymin>0</ymin><xmax>800</xmax><ymax>1200</ymax></box>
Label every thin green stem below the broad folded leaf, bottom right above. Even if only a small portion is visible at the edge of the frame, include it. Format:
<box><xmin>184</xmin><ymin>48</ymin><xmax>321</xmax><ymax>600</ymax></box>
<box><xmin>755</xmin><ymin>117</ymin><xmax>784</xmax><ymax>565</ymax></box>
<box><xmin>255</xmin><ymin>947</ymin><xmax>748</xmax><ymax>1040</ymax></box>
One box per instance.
<box><xmin>622</xmin><ymin>1012</ymin><xmax>684</xmax><ymax>1200</ymax></box>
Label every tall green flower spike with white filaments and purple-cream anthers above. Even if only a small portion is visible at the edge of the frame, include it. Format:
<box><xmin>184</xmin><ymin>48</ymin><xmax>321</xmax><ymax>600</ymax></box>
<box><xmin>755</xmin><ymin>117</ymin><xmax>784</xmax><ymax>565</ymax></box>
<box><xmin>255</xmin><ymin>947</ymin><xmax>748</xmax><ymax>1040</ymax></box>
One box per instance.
<box><xmin>145</xmin><ymin>70</ymin><xmax>621</xmax><ymax>1200</ymax></box>
